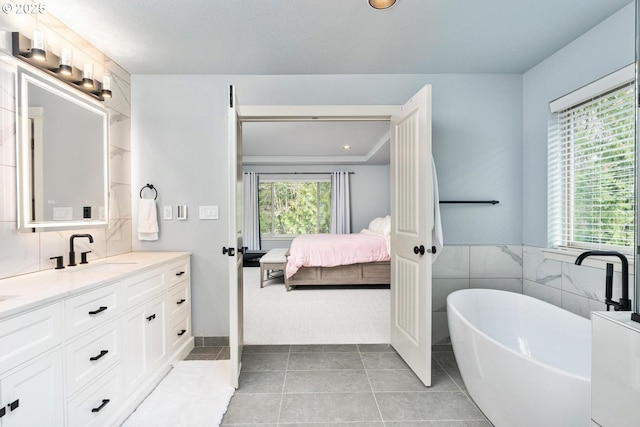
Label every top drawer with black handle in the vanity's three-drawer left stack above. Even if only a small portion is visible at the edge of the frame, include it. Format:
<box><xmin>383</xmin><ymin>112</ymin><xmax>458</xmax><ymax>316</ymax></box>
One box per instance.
<box><xmin>65</xmin><ymin>281</ymin><xmax>122</xmax><ymax>339</ymax></box>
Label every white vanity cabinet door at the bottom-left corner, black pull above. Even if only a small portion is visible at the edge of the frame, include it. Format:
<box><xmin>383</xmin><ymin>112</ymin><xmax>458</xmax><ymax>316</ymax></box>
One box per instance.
<box><xmin>0</xmin><ymin>350</ymin><xmax>64</xmax><ymax>427</ymax></box>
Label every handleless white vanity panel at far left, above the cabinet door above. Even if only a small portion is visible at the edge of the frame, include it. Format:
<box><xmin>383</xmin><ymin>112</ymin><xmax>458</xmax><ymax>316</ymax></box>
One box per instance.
<box><xmin>0</xmin><ymin>302</ymin><xmax>63</xmax><ymax>373</ymax></box>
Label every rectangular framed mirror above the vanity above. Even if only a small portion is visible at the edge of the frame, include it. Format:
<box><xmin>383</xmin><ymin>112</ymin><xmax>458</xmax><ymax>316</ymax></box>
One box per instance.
<box><xmin>16</xmin><ymin>67</ymin><xmax>109</xmax><ymax>231</ymax></box>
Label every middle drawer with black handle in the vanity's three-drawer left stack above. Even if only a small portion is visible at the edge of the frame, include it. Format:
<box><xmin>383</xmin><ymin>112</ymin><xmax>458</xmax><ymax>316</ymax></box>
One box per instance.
<box><xmin>65</xmin><ymin>320</ymin><xmax>122</xmax><ymax>396</ymax></box>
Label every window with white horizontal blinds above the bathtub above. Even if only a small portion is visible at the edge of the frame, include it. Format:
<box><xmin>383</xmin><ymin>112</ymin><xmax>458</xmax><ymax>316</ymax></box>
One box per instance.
<box><xmin>548</xmin><ymin>72</ymin><xmax>635</xmax><ymax>253</ymax></box>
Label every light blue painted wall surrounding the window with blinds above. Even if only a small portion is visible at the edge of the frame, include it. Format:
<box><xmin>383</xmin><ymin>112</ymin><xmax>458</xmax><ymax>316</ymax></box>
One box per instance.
<box><xmin>522</xmin><ymin>1</ymin><xmax>635</xmax><ymax>247</ymax></box>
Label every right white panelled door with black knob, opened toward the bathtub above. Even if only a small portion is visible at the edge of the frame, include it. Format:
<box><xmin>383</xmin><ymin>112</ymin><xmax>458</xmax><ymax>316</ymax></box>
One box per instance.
<box><xmin>391</xmin><ymin>86</ymin><xmax>433</xmax><ymax>386</ymax></box>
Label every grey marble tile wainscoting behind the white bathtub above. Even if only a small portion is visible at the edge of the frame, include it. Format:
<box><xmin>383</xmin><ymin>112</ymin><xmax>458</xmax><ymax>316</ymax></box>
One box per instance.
<box><xmin>433</xmin><ymin>245</ymin><xmax>635</xmax><ymax>344</ymax></box>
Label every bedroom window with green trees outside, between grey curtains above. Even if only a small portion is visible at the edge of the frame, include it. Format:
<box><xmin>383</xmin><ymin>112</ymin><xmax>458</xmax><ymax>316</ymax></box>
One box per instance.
<box><xmin>258</xmin><ymin>180</ymin><xmax>331</xmax><ymax>238</ymax></box>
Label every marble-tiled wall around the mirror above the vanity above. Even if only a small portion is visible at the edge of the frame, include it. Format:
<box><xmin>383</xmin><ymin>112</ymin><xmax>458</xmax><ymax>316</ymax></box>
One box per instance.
<box><xmin>0</xmin><ymin>13</ymin><xmax>131</xmax><ymax>278</ymax></box>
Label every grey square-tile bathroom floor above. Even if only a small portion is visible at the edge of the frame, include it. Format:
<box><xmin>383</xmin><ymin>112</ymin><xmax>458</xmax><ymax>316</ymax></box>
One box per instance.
<box><xmin>188</xmin><ymin>344</ymin><xmax>491</xmax><ymax>427</ymax></box>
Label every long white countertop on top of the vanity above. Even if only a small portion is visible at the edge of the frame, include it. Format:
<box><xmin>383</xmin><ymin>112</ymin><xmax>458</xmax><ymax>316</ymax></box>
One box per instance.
<box><xmin>0</xmin><ymin>252</ymin><xmax>189</xmax><ymax>319</ymax></box>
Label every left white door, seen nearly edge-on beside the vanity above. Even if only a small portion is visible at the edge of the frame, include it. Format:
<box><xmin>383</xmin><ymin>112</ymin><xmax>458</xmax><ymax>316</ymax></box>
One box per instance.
<box><xmin>223</xmin><ymin>86</ymin><xmax>244</xmax><ymax>388</ymax></box>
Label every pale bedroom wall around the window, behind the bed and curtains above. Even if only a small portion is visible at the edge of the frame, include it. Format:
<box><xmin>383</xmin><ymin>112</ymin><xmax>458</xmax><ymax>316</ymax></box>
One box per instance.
<box><xmin>244</xmin><ymin>165</ymin><xmax>391</xmax><ymax>250</ymax></box>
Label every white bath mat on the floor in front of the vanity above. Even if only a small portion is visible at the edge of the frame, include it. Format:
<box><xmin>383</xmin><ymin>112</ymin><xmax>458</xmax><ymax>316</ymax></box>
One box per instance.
<box><xmin>123</xmin><ymin>360</ymin><xmax>234</xmax><ymax>427</ymax></box>
